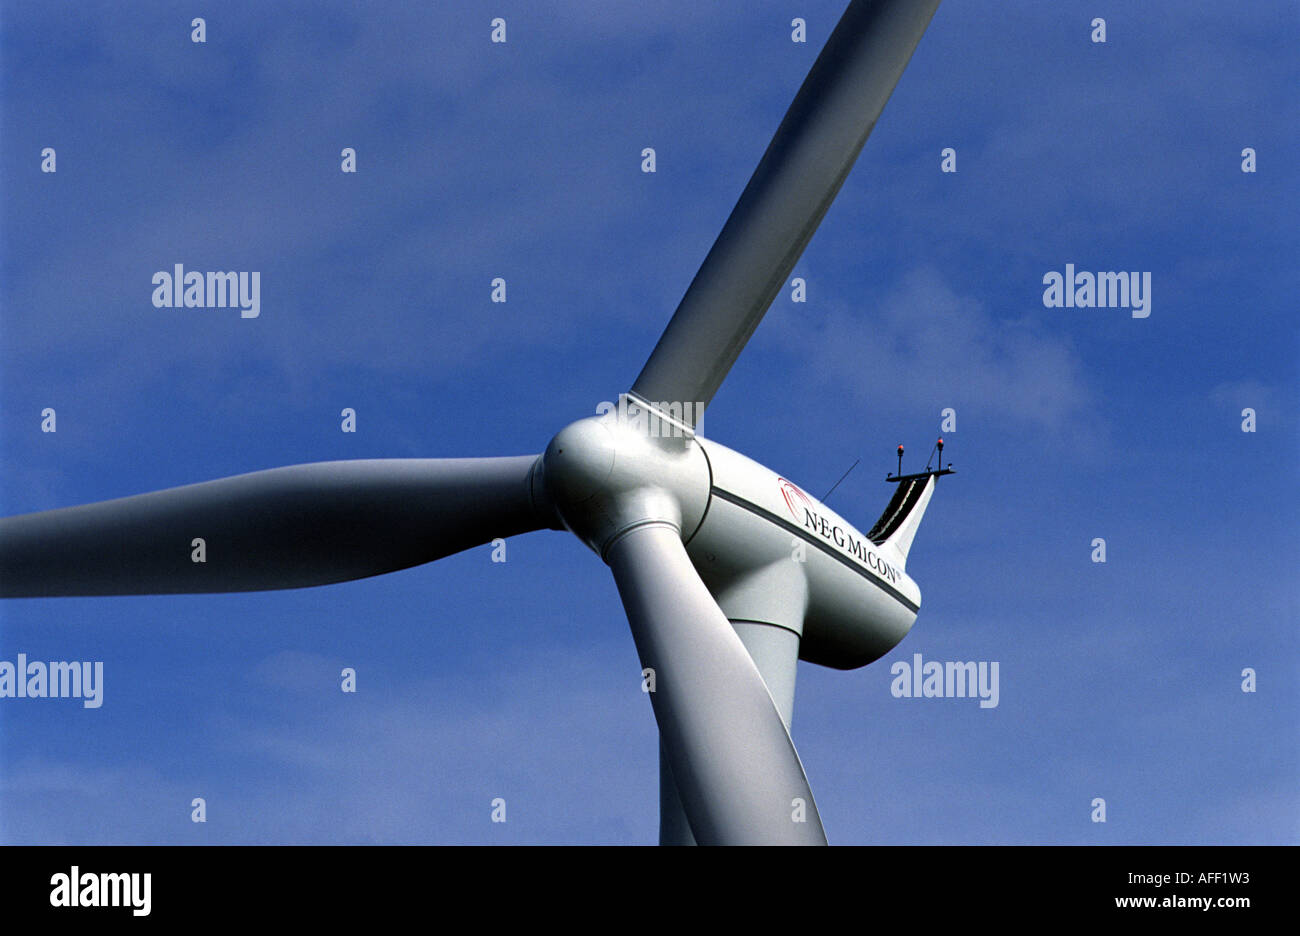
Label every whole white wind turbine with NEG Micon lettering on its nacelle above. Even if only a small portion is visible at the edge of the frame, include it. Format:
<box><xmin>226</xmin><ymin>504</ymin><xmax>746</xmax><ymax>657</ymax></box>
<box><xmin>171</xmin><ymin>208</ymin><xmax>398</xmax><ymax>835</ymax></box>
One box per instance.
<box><xmin>0</xmin><ymin>0</ymin><xmax>949</xmax><ymax>844</ymax></box>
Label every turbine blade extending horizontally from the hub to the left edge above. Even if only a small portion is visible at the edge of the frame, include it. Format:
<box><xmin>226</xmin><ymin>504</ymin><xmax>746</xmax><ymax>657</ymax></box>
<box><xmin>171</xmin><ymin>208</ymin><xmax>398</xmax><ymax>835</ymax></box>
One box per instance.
<box><xmin>0</xmin><ymin>456</ymin><xmax>558</xmax><ymax>597</ymax></box>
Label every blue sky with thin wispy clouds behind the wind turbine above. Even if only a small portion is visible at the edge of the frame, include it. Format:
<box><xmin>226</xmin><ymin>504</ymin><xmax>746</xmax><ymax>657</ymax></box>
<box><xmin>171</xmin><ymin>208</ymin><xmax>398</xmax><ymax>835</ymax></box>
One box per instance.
<box><xmin>0</xmin><ymin>0</ymin><xmax>1300</xmax><ymax>844</ymax></box>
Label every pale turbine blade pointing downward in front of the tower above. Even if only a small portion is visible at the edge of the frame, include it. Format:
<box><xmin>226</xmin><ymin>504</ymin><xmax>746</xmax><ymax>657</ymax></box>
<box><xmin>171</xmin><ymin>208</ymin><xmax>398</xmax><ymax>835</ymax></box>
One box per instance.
<box><xmin>606</xmin><ymin>524</ymin><xmax>826</xmax><ymax>845</ymax></box>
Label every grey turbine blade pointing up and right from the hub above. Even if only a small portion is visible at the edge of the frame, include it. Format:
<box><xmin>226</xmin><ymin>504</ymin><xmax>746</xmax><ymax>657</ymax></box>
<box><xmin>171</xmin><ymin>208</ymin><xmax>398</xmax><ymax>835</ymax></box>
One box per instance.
<box><xmin>632</xmin><ymin>0</ymin><xmax>939</xmax><ymax>424</ymax></box>
